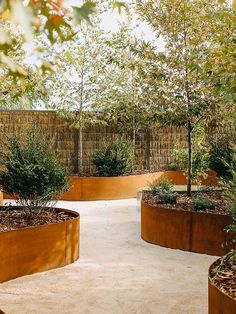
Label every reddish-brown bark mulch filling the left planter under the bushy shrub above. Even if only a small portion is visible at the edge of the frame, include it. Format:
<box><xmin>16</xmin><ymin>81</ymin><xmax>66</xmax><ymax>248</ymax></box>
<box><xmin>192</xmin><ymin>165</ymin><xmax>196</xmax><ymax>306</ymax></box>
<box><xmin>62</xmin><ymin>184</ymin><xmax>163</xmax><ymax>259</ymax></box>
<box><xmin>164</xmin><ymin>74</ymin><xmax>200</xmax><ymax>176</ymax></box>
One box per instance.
<box><xmin>0</xmin><ymin>206</ymin><xmax>74</xmax><ymax>232</ymax></box>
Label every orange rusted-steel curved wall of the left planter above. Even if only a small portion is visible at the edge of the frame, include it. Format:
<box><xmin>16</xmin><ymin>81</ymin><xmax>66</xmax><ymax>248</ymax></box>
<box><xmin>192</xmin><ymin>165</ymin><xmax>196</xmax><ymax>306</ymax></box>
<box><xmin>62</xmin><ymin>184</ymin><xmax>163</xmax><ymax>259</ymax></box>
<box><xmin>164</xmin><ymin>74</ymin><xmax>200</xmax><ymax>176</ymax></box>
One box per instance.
<box><xmin>0</xmin><ymin>209</ymin><xmax>80</xmax><ymax>282</ymax></box>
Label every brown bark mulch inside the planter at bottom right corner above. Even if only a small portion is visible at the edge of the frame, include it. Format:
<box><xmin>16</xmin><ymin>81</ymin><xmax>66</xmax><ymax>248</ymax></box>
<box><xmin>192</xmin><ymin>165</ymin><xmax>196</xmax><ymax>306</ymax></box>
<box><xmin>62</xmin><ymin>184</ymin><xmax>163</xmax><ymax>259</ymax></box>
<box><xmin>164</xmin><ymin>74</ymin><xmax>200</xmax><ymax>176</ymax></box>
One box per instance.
<box><xmin>210</xmin><ymin>251</ymin><xmax>236</xmax><ymax>300</ymax></box>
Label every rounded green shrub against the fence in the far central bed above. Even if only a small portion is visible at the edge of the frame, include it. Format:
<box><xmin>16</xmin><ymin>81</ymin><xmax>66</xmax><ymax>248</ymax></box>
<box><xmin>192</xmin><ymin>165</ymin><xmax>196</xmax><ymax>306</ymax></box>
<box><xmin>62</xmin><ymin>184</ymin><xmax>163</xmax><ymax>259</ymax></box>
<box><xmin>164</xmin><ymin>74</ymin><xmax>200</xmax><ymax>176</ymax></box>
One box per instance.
<box><xmin>93</xmin><ymin>138</ymin><xmax>134</xmax><ymax>177</ymax></box>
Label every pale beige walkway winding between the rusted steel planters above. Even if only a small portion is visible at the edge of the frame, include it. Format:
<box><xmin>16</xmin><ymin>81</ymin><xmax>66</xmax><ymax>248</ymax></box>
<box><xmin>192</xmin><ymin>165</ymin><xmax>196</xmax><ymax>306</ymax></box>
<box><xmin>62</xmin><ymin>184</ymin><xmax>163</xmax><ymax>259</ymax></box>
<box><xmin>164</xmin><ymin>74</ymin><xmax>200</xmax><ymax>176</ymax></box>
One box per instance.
<box><xmin>0</xmin><ymin>199</ymin><xmax>215</xmax><ymax>314</ymax></box>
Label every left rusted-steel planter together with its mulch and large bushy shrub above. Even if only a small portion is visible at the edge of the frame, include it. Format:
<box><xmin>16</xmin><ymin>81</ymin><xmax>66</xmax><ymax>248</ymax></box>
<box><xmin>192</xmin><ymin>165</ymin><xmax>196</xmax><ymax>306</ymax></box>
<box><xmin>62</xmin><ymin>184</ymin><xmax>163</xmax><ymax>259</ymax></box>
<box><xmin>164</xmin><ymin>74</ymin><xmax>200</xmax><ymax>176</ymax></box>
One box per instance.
<box><xmin>0</xmin><ymin>124</ymin><xmax>79</xmax><ymax>282</ymax></box>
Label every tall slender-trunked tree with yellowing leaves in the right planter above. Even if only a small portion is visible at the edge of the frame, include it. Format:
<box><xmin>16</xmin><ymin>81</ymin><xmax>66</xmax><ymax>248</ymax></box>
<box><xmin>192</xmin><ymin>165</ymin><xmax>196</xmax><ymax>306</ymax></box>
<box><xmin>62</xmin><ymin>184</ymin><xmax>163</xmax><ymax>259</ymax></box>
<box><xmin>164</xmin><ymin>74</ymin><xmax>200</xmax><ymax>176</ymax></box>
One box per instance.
<box><xmin>138</xmin><ymin>0</ymin><xmax>233</xmax><ymax>196</ymax></box>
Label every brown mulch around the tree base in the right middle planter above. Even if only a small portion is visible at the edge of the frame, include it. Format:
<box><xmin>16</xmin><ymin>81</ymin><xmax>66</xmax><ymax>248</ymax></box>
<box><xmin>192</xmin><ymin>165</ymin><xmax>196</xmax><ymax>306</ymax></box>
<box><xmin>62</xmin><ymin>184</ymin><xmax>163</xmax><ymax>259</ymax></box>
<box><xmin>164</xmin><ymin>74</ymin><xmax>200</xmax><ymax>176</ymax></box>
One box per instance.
<box><xmin>142</xmin><ymin>190</ymin><xmax>228</xmax><ymax>214</ymax></box>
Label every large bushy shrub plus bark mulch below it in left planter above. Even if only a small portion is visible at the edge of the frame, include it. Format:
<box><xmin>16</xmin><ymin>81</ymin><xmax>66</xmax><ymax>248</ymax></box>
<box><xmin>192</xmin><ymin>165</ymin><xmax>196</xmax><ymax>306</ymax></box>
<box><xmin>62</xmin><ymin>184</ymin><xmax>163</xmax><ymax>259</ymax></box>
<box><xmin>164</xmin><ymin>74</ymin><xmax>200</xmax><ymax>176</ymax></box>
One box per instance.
<box><xmin>0</xmin><ymin>124</ymin><xmax>69</xmax><ymax>231</ymax></box>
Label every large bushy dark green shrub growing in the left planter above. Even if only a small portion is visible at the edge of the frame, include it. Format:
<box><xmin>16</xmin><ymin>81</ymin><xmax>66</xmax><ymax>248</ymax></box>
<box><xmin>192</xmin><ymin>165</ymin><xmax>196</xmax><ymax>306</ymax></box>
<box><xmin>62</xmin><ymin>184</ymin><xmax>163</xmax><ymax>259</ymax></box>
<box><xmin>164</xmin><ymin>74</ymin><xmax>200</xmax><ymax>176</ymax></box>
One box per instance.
<box><xmin>0</xmin><ymin>124</ymin><xmax>69</xmax><ymax>207</ymax></box>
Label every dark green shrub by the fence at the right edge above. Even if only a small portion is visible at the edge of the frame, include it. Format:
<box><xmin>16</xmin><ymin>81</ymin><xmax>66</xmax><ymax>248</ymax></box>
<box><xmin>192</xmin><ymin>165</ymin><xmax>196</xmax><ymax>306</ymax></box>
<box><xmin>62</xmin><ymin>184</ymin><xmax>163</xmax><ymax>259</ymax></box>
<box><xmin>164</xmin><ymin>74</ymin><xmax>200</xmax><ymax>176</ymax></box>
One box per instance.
<box><xmin>209</xmin><ymin>139</ymin><xmax>234</xmax><ymax>179</ymax></box>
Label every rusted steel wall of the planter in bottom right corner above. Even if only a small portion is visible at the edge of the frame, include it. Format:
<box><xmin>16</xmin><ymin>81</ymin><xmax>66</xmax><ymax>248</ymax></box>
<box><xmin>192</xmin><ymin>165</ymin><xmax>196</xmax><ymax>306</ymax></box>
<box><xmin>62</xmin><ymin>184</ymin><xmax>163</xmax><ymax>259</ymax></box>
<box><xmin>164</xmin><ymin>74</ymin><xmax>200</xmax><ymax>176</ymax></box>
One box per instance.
<box><xmin>208</xmin><ymin>261</ymin><xmax>236</xmax><ymax>314</ymax></box>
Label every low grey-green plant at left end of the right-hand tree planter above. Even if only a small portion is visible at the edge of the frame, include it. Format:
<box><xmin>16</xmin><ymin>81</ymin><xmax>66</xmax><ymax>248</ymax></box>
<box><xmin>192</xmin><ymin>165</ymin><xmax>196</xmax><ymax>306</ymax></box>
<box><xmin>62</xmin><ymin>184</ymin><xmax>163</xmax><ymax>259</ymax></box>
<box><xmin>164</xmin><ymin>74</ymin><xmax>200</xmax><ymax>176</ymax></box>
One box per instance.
<box><xmin>149</xmin><ymin>179</ymin><xmax>178</xmax><ymax>204</ymax></box>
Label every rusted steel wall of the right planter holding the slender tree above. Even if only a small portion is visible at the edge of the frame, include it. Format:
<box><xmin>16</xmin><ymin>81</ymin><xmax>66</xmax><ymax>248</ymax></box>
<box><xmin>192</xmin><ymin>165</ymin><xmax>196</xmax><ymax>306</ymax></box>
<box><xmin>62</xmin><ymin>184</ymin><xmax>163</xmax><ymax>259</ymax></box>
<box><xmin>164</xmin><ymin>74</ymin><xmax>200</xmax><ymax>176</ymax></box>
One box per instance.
<box><xmin>141</xmin><ymin>202</ymin><xmax>234</xmax><ymax>256</ymax></box>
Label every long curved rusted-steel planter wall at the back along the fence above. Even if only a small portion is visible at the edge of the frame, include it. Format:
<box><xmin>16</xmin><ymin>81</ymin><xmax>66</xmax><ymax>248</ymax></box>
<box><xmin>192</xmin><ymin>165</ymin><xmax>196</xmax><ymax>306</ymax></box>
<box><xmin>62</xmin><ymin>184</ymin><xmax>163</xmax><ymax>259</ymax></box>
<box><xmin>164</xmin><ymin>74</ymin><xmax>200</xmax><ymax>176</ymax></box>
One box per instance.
<box><xmin>4</xmin><ymin>171</ymin><xmax>218</xmax><ymax>201</ymax></box>
